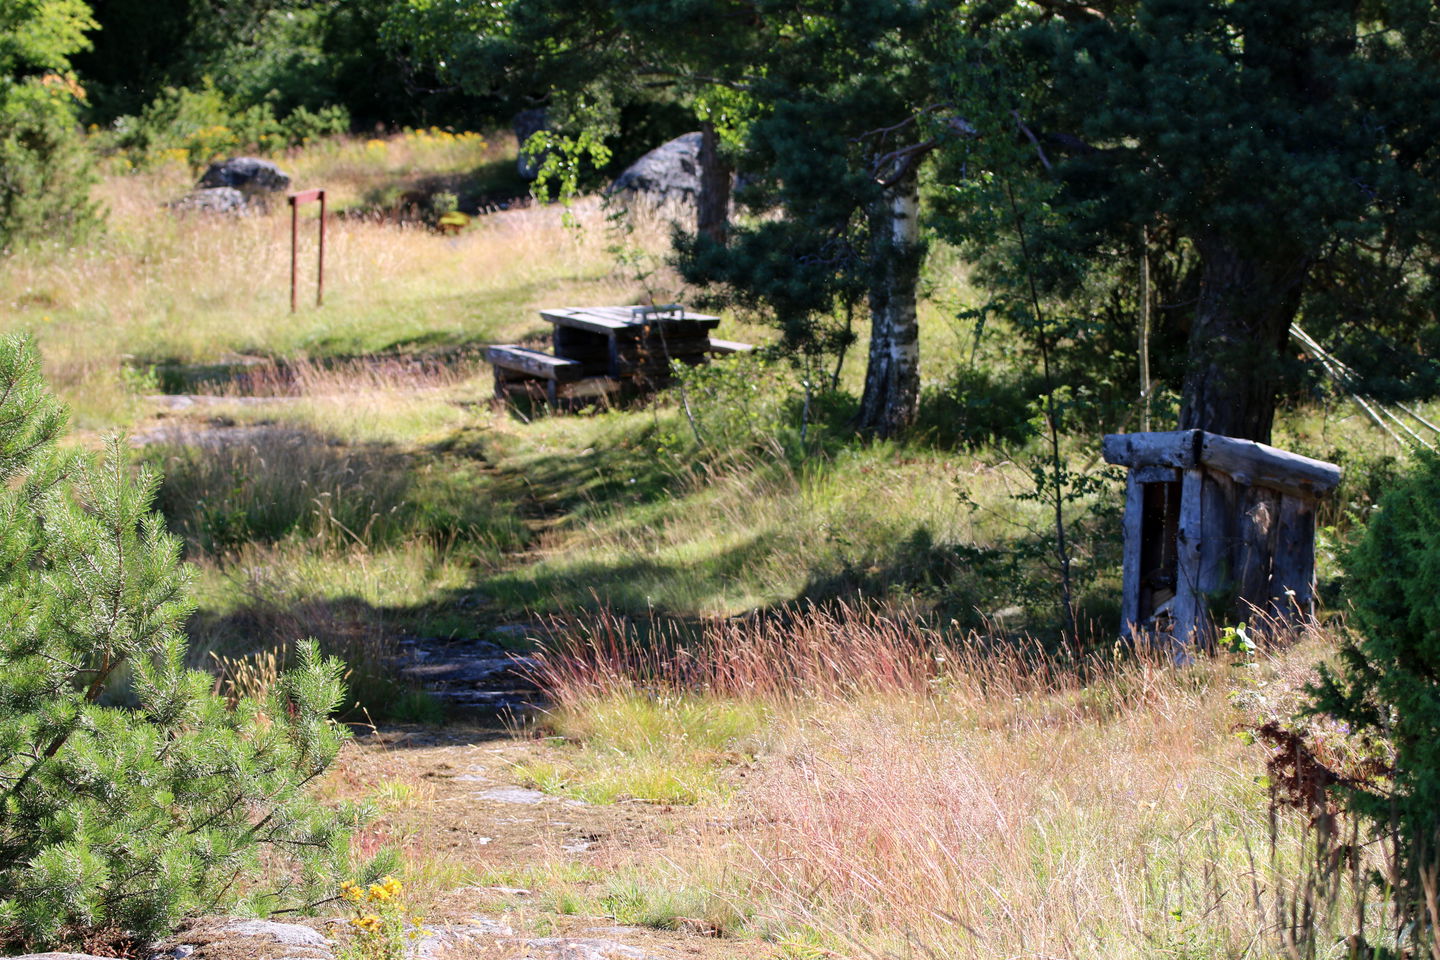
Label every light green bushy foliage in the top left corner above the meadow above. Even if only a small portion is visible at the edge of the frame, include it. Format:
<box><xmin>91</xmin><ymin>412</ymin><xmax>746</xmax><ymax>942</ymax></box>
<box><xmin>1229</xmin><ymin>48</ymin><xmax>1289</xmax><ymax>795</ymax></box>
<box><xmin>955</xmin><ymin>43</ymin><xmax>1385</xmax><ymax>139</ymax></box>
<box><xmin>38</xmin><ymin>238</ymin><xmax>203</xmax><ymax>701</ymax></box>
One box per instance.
<box><xmin>0</xmin><ymin>0</ymin><xmax>96</xmax><ymax>250</ymax></box>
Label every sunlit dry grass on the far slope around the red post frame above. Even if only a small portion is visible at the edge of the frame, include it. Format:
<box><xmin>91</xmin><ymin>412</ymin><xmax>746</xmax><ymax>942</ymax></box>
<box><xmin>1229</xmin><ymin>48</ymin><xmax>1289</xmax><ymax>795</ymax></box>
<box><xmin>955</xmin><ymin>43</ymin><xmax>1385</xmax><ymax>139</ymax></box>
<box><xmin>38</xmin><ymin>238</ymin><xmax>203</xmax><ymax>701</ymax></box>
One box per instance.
<box><xmin>0</xmin><ymin>137</ymin><xmax>696</xmax><ymax>429</ymax></box>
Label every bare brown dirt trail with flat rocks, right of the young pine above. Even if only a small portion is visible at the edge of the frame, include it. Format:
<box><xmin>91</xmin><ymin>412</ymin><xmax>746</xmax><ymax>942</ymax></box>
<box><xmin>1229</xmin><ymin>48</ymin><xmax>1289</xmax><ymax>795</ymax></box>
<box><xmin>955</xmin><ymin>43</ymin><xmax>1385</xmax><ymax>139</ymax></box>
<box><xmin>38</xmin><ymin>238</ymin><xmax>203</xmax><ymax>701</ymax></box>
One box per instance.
<box><xmin>331</xmin><ymin>725</ymin><xmax>748</xmax><ymax>960</ymax></box>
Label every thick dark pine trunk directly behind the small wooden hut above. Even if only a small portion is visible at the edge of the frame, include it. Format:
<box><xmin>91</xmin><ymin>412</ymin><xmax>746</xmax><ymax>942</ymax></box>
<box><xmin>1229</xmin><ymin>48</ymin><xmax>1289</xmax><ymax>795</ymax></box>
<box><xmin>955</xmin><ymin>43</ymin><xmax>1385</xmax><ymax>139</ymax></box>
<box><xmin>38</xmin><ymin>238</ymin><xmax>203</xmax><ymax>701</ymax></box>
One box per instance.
<box><xmin>1179</xmin><ymin>239</ymin><xmax>1310</xmax><ymax>443</ymax></box>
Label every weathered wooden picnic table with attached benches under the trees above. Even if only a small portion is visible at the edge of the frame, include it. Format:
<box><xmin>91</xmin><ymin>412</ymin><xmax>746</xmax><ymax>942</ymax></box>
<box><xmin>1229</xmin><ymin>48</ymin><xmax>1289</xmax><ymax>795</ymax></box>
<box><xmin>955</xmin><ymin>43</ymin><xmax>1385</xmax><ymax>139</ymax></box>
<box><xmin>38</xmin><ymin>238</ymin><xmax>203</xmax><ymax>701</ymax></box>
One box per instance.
<box><xmin>488</xmin><ymin>304</ymin><xmax>750</xmax><ymax>404</ymax></box>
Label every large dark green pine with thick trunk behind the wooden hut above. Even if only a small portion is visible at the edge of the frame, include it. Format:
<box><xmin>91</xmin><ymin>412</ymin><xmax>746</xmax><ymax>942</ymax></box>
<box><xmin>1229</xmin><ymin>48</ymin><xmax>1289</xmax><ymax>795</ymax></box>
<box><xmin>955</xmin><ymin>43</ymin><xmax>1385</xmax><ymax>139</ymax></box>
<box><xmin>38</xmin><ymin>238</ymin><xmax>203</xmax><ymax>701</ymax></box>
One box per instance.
<box><xmin>946</xmin><ymin>0</ymin><xmax>1440</xmax><ymax>440</ymax></box>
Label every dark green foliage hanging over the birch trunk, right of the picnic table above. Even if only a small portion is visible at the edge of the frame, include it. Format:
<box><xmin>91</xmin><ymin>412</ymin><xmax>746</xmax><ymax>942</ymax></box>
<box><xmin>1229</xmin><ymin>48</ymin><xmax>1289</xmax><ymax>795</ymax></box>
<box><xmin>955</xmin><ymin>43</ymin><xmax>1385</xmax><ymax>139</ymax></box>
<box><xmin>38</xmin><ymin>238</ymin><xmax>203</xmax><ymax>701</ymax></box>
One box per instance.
<box><xmin>675</xmin><ymin>1</ymin><xmax>959</xmax><ymax>379</ymax></box>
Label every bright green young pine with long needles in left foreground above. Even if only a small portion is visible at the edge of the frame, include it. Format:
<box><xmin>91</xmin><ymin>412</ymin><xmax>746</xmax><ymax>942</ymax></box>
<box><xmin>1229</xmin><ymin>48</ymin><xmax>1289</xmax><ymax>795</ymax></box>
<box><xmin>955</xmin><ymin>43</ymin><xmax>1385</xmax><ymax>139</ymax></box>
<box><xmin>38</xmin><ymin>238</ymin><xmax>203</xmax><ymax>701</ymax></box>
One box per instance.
<box><xmin>0</xmin><ymin>338</ymin><xmax>347</xmax><ymax>946</ymax></box>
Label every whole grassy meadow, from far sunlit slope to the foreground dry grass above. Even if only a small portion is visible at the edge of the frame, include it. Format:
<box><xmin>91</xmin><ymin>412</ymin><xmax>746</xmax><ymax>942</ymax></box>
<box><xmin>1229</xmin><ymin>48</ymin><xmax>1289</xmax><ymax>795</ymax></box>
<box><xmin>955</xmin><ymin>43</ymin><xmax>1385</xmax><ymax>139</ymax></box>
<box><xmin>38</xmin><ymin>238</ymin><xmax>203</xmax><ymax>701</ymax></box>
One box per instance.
<box><xmin>0</xmin><ymin>131</ymin><xmax>1403</xmax><ymax>959</ymax></box>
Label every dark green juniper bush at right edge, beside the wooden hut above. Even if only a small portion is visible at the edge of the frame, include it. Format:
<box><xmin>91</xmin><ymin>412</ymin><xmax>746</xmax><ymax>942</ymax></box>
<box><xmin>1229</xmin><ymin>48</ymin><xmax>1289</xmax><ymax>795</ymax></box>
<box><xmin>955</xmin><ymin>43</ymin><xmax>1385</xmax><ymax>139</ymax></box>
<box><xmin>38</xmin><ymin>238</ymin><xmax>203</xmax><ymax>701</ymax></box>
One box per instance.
<box><xmin>1310</xmin><ymin>453</ymin><xmax>1440</xmax><ymax>938</ymax></box>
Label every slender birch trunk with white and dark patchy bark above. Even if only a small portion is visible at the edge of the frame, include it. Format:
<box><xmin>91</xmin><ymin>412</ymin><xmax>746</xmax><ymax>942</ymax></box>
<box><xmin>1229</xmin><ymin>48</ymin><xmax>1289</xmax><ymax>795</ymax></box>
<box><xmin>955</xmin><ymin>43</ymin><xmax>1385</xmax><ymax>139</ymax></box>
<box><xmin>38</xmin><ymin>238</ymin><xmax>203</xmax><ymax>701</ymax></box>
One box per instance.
<box><xmin>855</xmin><ymin>173</ymin><xmax>924</xmax><ymax>436</ymax></box>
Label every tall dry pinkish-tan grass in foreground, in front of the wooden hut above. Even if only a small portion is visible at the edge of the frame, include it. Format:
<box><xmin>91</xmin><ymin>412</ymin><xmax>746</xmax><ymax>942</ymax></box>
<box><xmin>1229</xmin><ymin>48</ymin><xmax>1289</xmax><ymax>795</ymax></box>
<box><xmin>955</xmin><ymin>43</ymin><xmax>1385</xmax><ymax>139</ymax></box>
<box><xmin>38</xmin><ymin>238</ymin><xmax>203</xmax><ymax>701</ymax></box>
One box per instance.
<box><xmin>527</xmin><ymin>606</ymin><xmax>1344</xmax><ymax>959</ymax></box>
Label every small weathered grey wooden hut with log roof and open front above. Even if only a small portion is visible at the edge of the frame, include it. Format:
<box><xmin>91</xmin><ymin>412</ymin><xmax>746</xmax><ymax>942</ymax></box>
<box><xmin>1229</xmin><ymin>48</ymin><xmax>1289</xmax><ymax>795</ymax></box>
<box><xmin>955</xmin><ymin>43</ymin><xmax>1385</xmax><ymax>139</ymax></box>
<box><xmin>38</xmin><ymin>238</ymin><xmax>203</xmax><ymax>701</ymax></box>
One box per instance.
<box><xmin>1104</xmin><ymin>430</ymin><xmax>1341</xmax><ymax>645</ymax></box>
